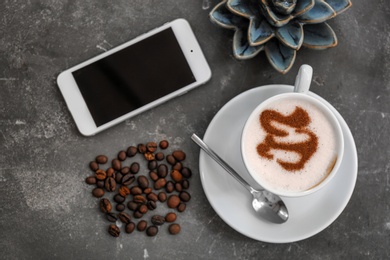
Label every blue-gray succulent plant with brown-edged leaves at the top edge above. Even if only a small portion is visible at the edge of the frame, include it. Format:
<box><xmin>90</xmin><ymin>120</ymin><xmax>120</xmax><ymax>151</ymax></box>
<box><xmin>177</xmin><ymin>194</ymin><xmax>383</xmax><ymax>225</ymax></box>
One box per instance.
<box><xmin>210</xmin><ymin>0</ymin><xmax>352</xmax><ymax>74</ymax></box>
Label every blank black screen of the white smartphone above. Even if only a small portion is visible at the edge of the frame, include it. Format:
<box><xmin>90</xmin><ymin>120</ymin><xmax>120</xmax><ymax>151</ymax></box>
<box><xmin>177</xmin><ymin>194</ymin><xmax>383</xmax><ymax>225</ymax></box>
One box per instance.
<box><xmin>73</xmin><ymin>28</ymin><xmax>195</xmax><ymax>126</ymax></box>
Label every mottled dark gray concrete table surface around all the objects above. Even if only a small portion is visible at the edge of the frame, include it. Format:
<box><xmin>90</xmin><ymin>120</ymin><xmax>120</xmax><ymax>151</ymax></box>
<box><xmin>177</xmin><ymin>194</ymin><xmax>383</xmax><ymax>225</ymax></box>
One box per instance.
<box><xmin>0</xmin><ymin>0</ymin><xmax>390</xmax><ymax>259</ymax></box>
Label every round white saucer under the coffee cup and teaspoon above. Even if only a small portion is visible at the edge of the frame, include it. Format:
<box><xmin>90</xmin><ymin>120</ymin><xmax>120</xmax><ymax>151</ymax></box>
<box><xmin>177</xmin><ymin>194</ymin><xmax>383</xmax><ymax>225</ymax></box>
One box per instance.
<box><xmin>199</xmin><ymin>85</ymin><xmax>357</xmax><ymax>243</ymax></box>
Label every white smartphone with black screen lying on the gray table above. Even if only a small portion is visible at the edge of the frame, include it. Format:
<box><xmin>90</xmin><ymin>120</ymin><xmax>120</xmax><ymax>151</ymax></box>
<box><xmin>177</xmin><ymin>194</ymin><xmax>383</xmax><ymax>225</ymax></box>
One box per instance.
<box><xmin>57</xmin><ymin>19</ymin><xmax>211</xmax><ymax>136</ymax></box>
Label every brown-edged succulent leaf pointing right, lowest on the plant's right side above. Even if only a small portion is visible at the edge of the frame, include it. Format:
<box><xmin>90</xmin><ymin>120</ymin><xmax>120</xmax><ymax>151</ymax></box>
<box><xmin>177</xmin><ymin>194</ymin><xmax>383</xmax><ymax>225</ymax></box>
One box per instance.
<box><xmin>303</xmin><ymin>23</ymin><xmax>338</xmax><ymax>50</ymax></box>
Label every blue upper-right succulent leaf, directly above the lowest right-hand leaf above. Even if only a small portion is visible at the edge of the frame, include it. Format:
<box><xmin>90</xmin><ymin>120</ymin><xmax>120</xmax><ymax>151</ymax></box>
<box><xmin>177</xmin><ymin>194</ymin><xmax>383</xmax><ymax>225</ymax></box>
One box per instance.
<box><xmin>298</xmin><ymin>0</ymin><xmax>336</xmax><ymax>24</ymax></box>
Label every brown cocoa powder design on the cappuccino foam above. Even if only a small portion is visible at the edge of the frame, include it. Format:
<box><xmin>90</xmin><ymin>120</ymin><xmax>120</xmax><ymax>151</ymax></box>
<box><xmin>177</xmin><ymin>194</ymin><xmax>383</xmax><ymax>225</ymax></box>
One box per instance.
<box><xmin>257</xmin><ymin>106</ymin><xmax>318</xmax><ymax>171</ymax></box>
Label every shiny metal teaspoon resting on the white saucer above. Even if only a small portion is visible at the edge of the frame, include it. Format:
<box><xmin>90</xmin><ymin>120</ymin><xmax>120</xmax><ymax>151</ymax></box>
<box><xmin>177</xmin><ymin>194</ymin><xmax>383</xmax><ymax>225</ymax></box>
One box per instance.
<box><xmin>191</xmin><ymin>134</ymin><xmax>289</xmax><ymax>224</ymax></box>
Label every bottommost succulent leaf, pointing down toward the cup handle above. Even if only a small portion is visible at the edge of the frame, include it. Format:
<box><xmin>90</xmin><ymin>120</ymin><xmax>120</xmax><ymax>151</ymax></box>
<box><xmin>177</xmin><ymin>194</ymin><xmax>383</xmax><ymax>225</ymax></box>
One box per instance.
<box><xmin>264</xmin><ymin>40</ymin><xmax>296</xmax><ymax>74</ymax></box>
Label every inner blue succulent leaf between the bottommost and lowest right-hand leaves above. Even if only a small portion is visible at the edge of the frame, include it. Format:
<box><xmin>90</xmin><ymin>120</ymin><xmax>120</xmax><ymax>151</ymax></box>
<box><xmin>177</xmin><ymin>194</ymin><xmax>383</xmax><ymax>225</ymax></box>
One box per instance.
<box><xmin>276</xmin><ymin>21</ymin><xmax>303</xmax><ymax>50</ymax></box>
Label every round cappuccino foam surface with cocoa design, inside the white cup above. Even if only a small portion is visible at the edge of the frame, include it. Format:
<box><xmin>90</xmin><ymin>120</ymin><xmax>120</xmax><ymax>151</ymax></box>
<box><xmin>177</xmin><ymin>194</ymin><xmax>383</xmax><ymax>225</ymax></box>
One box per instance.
<box><xmin>242</xmin><ymin>98</ymin><xmax>337</xmax><ymax>192</ymax></box>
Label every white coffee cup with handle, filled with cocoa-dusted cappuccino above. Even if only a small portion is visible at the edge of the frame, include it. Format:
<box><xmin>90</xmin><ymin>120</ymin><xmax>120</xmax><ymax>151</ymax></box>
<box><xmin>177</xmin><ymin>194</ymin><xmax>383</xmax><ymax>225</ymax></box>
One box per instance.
<box><xmin>241</xmin><ymin>65</ymin><xmax>344</xmax><ymax>197</ymax></box>
